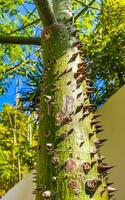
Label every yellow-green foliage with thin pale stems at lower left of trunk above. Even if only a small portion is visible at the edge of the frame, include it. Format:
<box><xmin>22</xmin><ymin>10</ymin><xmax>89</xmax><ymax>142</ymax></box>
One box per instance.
<box><xmin>0</xmin><ymin>104</ymin><xmax>37</xmax><ymax>196</ymax></box>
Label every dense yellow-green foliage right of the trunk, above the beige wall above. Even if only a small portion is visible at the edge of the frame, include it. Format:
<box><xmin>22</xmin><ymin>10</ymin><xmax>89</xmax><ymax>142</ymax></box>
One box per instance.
<box><xmin>74</xmin><ymin>0</ymin><xmax>125</xmax><ymax>105</ymax></box>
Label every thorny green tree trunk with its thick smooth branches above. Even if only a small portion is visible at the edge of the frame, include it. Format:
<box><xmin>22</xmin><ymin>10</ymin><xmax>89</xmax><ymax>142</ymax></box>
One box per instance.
<box><xmin>0</xmin><ymin>0</ymin><xmax>115</xmax><ymax>200</ymax></box>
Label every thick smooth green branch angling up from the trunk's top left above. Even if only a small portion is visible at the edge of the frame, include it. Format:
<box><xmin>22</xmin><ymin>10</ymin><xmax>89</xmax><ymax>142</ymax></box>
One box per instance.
<box><xmin>34</xmin><ymin>0</ymin><xmax>56</xmax><ymax>26</ymax></box>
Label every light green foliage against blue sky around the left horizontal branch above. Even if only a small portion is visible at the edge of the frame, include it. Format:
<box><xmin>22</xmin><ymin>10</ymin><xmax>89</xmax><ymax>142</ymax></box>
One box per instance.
<box><xmin>0</xmin><ymin>0</ymin><xmax>39</xmax><ymax>94</ymax></box>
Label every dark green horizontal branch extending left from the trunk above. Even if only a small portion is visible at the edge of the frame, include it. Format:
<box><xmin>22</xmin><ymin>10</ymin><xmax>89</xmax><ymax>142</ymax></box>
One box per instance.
<box><xmin>0</xmin><ymin>35</ymin><xmax>41</xmax><ymax>46</ymax></box>
